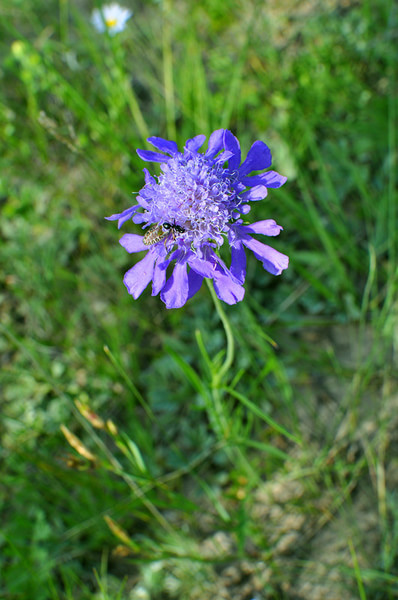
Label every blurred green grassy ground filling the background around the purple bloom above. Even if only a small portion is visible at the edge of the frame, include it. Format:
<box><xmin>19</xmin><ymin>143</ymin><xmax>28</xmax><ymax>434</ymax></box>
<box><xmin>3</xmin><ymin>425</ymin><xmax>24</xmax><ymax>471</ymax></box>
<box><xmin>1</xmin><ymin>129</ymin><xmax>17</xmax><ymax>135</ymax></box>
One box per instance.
<box><xmin>0</xmin><ymin>0</ymin><xmax>398</xmax><ymax>600</ymax></box>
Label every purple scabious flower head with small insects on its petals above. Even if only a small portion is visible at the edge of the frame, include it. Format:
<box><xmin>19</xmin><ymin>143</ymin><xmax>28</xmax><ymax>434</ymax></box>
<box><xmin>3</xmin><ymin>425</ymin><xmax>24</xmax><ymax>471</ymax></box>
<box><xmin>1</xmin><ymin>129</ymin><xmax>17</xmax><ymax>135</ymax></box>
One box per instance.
<box><xmin>107</xmin><ymin>129</ymin><xmax>289</xmax><ymax>308</ymax></box>
